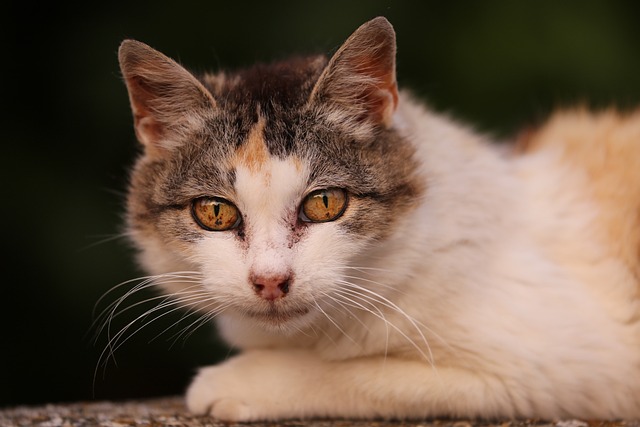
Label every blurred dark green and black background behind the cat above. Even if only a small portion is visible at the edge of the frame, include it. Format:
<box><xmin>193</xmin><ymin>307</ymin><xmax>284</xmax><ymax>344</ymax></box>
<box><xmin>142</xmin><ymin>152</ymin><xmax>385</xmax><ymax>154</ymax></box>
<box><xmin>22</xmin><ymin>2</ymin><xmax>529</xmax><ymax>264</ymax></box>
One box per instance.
<box><xmin>0</xmin><ymin>0</ymin><xmax>640</xmax><ymax>407</ymax></box>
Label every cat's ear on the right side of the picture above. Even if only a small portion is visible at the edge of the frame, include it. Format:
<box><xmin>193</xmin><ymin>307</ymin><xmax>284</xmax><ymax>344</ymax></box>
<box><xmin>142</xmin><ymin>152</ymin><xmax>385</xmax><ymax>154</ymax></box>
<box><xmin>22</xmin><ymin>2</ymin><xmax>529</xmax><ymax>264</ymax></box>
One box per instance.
<box><xmin>310</xmin><ymin>17</ymin><xmax>398</xmax><ymax>127</ymax></box>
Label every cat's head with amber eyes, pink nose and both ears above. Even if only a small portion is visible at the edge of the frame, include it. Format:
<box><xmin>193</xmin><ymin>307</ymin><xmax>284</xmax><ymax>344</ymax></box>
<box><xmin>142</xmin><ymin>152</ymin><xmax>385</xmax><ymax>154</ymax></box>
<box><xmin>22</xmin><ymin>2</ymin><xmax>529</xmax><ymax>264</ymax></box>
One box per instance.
<box><xmin>119</xmin><ymin>18</ymin><xmax>422</xmax><ymax>328</ymax></box>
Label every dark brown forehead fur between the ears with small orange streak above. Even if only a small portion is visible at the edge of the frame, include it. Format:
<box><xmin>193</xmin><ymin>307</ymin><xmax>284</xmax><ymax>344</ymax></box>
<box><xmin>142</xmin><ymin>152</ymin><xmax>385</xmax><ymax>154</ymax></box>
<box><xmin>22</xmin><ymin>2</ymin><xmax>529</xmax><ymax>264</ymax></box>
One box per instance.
<box><xmin>196</xmin><ymin>56</ymin><xmax>327</xmax><ymax>163</ymax></box>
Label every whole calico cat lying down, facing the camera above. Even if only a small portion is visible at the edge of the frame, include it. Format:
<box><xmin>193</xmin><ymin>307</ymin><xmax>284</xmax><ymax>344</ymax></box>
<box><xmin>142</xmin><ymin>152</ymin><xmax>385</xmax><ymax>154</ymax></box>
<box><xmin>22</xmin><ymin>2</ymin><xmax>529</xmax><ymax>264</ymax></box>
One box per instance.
<box><xmin>119</xmin><ymin>17</ymin><xmax>640</xmax><ymax>421</ymax></box>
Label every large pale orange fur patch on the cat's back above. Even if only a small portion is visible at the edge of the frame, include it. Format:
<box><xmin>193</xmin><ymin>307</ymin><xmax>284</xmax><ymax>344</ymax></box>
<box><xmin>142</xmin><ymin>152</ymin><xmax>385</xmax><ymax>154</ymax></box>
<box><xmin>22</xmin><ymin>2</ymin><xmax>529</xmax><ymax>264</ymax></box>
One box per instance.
<box><xmin>518</xmin><ymin>109</ymin><xmax>640</xmax><ymax>287</ymax></box>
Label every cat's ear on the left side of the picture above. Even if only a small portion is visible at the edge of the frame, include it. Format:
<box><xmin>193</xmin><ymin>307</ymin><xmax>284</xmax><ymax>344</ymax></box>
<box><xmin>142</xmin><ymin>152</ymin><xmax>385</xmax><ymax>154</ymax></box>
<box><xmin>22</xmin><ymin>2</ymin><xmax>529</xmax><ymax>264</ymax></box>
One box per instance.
<box><xmin>118</xmin><ymin>40</ymin><xmax>215</xmax><ymax>153</ymax></box>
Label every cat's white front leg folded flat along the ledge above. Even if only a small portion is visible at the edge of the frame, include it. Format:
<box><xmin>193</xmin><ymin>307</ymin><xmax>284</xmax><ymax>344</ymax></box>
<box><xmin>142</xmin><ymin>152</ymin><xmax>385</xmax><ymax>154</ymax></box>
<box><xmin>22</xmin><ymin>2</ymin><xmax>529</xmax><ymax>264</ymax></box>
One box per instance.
<box><xmin>187</xmin><ymin>350</ymin><xmax>500</xmax><ymax>421</ymax></box>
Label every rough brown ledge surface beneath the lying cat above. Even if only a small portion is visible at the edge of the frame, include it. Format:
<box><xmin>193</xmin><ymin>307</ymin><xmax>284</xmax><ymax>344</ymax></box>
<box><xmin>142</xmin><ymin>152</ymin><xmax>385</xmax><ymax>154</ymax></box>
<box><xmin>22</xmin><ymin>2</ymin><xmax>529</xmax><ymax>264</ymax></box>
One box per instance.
<box><xmin>0</xmin><ymin>397</ymin><xmax>640</xmax><ymax>427</ymax></box>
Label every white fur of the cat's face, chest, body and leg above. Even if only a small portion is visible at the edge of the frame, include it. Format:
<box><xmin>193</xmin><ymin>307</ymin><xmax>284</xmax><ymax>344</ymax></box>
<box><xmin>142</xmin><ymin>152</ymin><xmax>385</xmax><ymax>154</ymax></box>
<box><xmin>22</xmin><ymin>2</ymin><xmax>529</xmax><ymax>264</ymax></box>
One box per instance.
<box><xmin>174</xmin><ymin>97</ymin><xmax>640</xmax><ymax>421</ymax></box>
